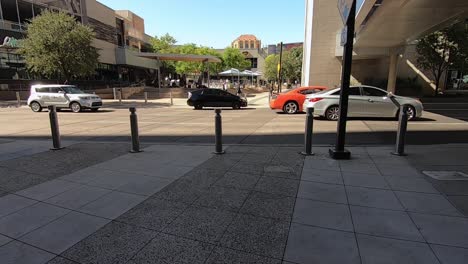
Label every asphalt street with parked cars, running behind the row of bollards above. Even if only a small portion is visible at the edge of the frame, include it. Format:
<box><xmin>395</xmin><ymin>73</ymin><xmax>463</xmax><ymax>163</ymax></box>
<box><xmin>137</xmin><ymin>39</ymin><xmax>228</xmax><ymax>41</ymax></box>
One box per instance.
<box><xmin>0</xmin><ymin>99</ymin><xmax>468</xmax><ymax>145</ymax></box>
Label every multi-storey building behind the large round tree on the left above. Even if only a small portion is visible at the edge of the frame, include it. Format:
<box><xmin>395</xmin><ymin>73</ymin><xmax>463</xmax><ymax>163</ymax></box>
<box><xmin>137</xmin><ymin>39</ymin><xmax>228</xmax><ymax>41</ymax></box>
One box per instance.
<box><xmin>0</xmin><ymin>0</ymin><xmax>159</xmax><ymax>87</ymax></box>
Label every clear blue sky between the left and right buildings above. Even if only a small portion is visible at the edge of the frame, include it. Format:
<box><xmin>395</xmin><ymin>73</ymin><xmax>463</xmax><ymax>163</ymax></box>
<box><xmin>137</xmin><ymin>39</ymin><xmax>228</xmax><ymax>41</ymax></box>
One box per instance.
<box><xmin>98</xmin><ymin>0</ymin><xmax>305</xmax><ymax>48</ymax></box>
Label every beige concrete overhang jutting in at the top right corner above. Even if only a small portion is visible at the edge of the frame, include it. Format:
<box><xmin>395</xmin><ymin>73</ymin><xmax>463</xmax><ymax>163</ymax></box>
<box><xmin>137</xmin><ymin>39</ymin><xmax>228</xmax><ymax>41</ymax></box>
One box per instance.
<box><xmin>355</xmin><ymin>0</ymin><xmax>468</xmax><ymax>49</ymax></box>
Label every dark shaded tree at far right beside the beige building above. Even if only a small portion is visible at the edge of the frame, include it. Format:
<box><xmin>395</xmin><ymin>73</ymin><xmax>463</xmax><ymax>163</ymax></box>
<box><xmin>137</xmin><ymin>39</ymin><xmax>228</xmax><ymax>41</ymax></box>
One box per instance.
<box><xmin>416</xmin><ymin>26</ymin><xmax>463</xmax><ymax>96</ymax></box>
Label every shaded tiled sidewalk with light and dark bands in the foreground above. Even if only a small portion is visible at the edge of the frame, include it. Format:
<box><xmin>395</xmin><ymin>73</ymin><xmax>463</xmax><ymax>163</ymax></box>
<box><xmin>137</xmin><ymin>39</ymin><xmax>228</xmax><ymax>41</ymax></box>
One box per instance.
<box><xmin>0</xmin><ymin>140</ymin><xmax>468</xmax><ymax>264</ymax></box>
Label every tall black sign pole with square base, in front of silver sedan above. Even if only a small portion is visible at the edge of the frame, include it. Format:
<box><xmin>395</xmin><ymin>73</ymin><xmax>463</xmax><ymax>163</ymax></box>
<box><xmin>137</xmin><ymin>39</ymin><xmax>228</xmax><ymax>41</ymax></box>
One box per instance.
<box><xmin>329</xmin><ymin>0</ymin><xmax>356</xmax><ymax>160</ymax></box>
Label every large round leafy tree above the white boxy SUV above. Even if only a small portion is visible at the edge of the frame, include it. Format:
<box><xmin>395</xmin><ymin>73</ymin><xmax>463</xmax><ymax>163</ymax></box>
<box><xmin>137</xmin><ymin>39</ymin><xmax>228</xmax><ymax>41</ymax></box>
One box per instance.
<box><xmin>20</xmin><ymin>11</ymin><xmax>99</xmax><ymax>83</ymax></box>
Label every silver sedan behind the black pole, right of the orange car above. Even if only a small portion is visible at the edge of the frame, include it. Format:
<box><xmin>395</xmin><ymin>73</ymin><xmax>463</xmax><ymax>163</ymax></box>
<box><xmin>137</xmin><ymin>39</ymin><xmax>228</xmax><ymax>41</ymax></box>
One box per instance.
<box><xmin>303</xmin><ymin>86</ymin><xmax>423</xmax><ymax>120</ymax></box>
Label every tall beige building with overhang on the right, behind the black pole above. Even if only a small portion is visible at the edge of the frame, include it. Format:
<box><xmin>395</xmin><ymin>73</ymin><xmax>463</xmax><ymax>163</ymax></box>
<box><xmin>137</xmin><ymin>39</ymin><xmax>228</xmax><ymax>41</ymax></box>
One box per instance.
<box><xmin>302</xmin><ymin>0</ymin><xmax>468</xmax><ymax>94</ymax></box>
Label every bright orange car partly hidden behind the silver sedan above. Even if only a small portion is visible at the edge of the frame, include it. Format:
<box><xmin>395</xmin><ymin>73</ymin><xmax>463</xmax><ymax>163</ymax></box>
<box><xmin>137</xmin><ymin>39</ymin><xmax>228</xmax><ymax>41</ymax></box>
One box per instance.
<box><xmin>270</xmin><ymin>86</ymin><xmax>328</xmax><ymax>114</ymax></box>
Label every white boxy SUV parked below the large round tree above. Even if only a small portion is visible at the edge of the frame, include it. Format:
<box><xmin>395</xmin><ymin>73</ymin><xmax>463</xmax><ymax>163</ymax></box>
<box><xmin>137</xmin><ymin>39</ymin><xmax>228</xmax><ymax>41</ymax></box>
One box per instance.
<box><xmin>28</xmin><ymin>85</ymin><xmax>102</xmax><ymax>113</ymax></box>
